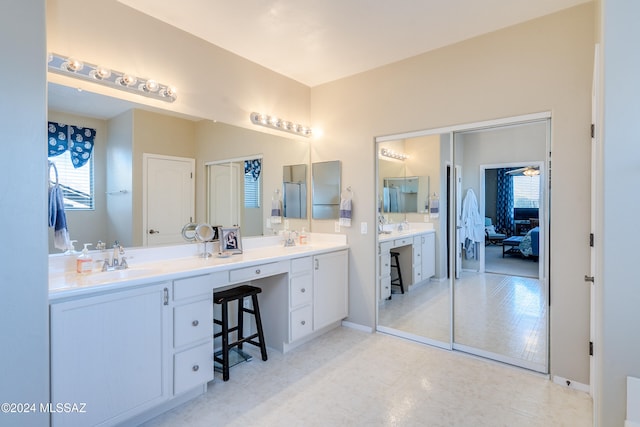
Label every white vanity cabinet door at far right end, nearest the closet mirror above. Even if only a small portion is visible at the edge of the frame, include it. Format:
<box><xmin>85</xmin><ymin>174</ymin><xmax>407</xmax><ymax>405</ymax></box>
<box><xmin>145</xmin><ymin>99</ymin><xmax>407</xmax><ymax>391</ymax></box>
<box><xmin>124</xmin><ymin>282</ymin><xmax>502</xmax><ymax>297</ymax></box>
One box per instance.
<box><xmin>313</xmin><ymin>250</ymin><xmax>349</xmax><ymax>330</ymax></box>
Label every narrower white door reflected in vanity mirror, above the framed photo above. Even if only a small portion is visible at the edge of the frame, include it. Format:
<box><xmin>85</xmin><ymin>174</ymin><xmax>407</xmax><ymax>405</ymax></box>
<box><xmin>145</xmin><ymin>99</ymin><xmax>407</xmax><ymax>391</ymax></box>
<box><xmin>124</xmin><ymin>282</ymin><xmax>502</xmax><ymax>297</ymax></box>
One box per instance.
<box><xmin>208</xmin><ymin>163</ymin><xmax>241</xmax><ymax>227</ymax></box>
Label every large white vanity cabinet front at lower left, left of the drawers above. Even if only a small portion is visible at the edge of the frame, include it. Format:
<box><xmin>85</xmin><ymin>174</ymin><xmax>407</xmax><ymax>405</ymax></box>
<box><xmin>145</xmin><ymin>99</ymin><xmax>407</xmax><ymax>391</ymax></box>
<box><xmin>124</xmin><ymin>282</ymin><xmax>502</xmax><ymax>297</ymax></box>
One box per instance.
<box><xmin>50</xmin><ymin>282</ymin><xmax>171</xmax><ymax>427</ymax></box>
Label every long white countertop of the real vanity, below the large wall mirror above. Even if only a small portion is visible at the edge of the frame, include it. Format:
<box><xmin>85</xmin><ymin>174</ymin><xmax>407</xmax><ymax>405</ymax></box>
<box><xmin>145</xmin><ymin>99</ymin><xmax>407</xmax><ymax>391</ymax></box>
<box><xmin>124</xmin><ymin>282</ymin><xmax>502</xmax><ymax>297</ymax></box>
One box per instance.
<box><xmin>49</xmin><ymin>233</ymin><xmax>349</xmax><ymax>301</ymax></box>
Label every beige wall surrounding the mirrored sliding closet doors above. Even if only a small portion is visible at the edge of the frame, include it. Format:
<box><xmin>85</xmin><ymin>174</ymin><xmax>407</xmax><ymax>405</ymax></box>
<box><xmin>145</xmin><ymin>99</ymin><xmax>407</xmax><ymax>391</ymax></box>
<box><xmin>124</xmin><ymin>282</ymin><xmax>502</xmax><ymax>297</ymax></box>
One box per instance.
<box><xmin>311</xmin><ymin>4</ymin><xmax>595</xmax><ymax>384</ymax></box>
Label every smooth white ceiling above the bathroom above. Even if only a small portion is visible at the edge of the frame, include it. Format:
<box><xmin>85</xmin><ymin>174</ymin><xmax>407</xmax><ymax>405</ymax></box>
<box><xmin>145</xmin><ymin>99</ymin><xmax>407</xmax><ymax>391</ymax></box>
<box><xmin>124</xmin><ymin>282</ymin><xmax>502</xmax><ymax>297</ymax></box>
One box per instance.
<box><xmin>118</xmin><ymin>0</ymin><xmax>591</xmax><ymax>87</ymax></box>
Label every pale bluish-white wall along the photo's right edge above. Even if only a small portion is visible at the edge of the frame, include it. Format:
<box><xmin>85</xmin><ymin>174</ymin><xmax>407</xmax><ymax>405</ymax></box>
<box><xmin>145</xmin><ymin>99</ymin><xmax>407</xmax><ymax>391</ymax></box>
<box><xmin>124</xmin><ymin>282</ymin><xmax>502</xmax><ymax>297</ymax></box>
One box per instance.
<box><xmin>594</xmin><ymin>0</ymin><xmax>640</xmax><ymax>426</ymax></box>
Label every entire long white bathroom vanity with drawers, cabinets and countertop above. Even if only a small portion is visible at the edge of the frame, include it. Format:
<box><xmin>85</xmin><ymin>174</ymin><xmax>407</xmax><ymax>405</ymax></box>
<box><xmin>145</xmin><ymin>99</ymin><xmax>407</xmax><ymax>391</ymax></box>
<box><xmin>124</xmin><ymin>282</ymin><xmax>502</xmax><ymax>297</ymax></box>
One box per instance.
<box><xmin>49</xmin><ymin>234</ymin><xmax>348</xmax><ymax>426</ymax></box>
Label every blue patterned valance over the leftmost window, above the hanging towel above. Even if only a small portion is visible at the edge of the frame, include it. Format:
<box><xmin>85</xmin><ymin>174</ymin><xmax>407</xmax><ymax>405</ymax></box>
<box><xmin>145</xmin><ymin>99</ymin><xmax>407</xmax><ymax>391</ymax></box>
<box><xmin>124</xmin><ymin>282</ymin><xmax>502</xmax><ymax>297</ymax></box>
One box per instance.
<box><xmin>48</xmin><ymin>122</ymin><xmax>96</xmax><ymax>169</ymax></box>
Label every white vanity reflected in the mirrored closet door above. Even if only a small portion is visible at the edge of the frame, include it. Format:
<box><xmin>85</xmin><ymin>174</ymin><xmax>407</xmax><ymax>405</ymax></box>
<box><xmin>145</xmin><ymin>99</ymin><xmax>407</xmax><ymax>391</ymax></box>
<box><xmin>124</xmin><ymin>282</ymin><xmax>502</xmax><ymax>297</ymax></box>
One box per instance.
<box><xmin>378</xmin><ymin>224</ymin><xmax>436</xmax><ymax>301</ymax></box>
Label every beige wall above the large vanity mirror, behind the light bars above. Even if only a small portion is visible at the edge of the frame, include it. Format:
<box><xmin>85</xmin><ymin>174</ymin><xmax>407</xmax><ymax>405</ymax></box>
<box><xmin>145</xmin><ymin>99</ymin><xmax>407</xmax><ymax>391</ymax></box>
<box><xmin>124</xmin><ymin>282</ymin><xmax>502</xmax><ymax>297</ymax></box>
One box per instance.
<box><xmin>46</xmin><ymin>0</ymin><xmax>310</xmax><ymax>135</ymax></box>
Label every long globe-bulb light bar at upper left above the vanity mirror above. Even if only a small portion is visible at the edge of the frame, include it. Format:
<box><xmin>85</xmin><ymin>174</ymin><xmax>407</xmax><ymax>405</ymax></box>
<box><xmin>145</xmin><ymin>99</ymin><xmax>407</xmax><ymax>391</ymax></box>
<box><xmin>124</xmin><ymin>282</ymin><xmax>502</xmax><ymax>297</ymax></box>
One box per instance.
<box><xmin>48</xmin><ymin>53</ymin><xmax>178</xmax><ymax>102</ymax></box>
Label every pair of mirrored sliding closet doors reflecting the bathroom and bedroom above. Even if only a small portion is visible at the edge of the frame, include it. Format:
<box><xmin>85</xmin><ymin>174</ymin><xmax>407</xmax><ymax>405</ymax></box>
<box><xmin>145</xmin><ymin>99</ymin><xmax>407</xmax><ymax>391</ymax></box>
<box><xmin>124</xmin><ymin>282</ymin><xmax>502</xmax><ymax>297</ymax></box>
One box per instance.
<box><xmin>376</xmin><ymin>114</ymin><xmax>550</xmax><ymax>372</ymax></box>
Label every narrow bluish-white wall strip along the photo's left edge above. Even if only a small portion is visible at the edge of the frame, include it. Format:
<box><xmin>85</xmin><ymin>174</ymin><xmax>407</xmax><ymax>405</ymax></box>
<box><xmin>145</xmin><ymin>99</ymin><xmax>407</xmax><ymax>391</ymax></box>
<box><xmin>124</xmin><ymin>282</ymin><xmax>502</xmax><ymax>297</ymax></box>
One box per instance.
<box><xmin>0</xmin><ymin>0</ymin><xmax>49</xmax><ymax>427</ymax></box>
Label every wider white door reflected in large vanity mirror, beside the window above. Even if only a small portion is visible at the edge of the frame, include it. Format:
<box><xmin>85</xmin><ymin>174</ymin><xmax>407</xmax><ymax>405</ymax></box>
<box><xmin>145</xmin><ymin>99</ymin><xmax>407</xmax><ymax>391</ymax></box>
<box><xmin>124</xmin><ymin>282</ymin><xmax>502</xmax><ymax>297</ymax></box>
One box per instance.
<box><xmin>142</xmin><ymin>154</ymin><xmax>195</xmax><ymax>246</ymax></box>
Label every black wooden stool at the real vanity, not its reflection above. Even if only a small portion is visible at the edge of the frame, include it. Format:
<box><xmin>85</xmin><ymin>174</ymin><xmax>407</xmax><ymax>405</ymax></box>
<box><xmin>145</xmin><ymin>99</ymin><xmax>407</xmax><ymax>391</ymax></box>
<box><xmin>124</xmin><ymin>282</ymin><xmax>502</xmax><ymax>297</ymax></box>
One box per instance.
<box><xmin>213</xmin><ymin>285</ymin><xmax>267</xmax><ymax>381</ymax></box>
